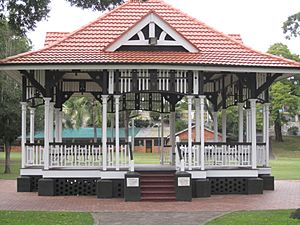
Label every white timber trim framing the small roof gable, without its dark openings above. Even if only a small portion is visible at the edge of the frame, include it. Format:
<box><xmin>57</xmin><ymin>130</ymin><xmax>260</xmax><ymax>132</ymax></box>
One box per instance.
<box><xmin>106</xmin><ymin>13</ymin><xmax>199</xmax><ymax>52</ymax></box>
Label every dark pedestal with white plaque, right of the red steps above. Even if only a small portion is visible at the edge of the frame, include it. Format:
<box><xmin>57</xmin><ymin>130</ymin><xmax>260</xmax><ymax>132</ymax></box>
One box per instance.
<box><xmin>175</xmin><ymin>172</ymin><xmax>192</xmax><ymax>201</ymax></box>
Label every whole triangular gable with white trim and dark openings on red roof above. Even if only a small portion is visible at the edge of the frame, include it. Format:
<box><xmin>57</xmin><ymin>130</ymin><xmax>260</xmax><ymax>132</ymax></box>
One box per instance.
<box><xmin>106</xmin><ymin>12</ymin><xmax>199</xmax><ymax>52</ymax></box>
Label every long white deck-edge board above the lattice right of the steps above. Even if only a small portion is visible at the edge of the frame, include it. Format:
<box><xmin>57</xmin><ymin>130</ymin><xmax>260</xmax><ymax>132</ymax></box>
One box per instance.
<box><xmin>206</xmin><ymin>169</ymin><xmax>258</xmax><ymax>177</ymax></box>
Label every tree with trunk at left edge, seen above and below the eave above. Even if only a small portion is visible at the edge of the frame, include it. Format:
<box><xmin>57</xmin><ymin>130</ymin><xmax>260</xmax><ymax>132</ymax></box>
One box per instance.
<box><xmin>0</xmin><ymin>20</ymin><xmax>31</xmax><ymax>173</ymax></box>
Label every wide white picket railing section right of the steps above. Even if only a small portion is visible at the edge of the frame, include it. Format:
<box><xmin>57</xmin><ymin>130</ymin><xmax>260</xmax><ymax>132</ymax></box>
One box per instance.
<box><xmin>204</xmin><ymin>143</ymin><xmax>251</xmax><ymax>167</ymax></box>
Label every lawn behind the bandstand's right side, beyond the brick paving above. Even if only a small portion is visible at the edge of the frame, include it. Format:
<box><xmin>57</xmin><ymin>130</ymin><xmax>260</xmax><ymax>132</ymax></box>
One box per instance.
<box><xmin>270</xmin><ymin>137</ymin><xmax>300</xmax><ymax>180</ymax></box>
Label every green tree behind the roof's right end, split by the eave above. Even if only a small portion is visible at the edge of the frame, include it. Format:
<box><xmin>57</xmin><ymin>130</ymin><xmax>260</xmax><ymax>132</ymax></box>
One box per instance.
<box><xmin>268</xmin><ymin>43</ymin><xmax>300</xmax><ymax>141</ymax></box>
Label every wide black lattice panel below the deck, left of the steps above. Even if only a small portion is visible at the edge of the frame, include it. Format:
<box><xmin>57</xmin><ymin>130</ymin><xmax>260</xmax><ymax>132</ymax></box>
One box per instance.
<box><xmin>55</xmin><ymin>178</ymin><xmax>99</xmax><ymax>196</ymax></box>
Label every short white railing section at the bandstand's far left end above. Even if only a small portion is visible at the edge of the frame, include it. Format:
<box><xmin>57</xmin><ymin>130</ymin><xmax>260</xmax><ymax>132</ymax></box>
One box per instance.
<box><xmin>25</xmin><ymin>144</ymin><xmax>44</xmax><ymax>167</ymax></box>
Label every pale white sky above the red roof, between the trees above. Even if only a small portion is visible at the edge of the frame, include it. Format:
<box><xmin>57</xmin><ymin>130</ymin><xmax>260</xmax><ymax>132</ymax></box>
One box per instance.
<box><xmin>28</xmin><ymin>0</ymin><xmax>300</xmax><ymax>55</ymax></box>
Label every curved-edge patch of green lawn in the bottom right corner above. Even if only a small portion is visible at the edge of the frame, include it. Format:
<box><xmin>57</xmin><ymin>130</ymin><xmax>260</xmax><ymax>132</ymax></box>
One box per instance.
<box><xmin>206</xmin><ymin>210</ymin><xmax>300</xmax><ymax>225</ymax></box>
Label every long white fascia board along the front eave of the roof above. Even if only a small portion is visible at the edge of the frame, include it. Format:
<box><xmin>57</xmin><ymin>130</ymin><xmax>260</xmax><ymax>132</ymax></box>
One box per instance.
<box><xmin>0</xmin><ymin>64</ymin><xmax>300</xmax><ymax>74</ymax></box>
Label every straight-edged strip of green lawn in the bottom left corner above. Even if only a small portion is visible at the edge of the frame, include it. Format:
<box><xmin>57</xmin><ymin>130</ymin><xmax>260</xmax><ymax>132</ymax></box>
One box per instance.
<box><xmin>0</xmin><ymin>211</ymin><xmax>93</xmax><ymax>225</ymax></box>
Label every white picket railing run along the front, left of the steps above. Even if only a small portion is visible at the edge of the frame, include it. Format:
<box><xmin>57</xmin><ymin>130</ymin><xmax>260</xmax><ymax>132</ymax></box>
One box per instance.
<box><xmin>49</xmin><ymin>143</ymin><xmax>130</xmax><ymax>169</ymax></box>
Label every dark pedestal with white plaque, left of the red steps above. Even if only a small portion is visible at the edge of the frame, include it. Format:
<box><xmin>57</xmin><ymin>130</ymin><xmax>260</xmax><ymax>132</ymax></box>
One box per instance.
<box><xmin>124</xmin><ymin>172</ymin><xmax>141</xmax><ymax>201</ymax></box>
